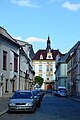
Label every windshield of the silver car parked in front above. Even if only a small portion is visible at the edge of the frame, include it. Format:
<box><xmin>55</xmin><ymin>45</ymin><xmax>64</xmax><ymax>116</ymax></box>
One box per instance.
<box><xmin>12</xmin><ymin>92</ymin><xmax>32</xmax><ymax>99</ymax></box>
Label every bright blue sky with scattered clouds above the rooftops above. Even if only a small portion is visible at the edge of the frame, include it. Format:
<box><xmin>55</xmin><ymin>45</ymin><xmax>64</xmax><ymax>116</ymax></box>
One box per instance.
<box><xmin>0</xmin><ymin>0</ymin><xmax>80</xmax><ymax>53</ymax></box>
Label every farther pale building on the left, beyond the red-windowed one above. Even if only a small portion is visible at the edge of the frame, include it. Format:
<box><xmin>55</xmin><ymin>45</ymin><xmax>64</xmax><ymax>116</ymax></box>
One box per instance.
<box><xmin>17</xmin><ymin>40</ymin><xmax>34</xmax><ymax>90</ymax></box>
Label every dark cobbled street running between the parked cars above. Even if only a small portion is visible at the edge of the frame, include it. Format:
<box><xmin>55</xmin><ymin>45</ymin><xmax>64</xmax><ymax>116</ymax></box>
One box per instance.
<box><xmin>0</xmin><ymin>94</ymin><xmax>80</xmax><ymax>120</ymax></box>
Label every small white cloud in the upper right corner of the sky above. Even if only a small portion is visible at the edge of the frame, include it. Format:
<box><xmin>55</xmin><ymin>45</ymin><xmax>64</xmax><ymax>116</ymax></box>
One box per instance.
<box><xmin>62</xmin><ymin>1</ymin><xmax>80</xmax><ymax>11</ymax></box>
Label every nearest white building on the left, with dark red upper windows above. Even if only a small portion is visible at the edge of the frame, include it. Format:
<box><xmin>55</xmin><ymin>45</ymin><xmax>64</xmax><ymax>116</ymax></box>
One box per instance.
<box><xmin>0</xmin><ymin>27</ymin><xmax>20</xmax><ymax>97</ymax></box>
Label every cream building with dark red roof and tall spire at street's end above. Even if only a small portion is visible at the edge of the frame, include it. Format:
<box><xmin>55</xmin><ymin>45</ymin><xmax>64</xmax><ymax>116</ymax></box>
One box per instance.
<box><xmin>33</xmin><ymin>36</ymin><xmax>62</xmax><ymax>89</ymax></box>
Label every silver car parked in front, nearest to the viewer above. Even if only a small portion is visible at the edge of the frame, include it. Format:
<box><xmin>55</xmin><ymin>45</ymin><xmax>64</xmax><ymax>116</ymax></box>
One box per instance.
<box><xmin>8</xmin><ymin>90</ymin><xmax>36</xmax><ymax>112</ymax></box>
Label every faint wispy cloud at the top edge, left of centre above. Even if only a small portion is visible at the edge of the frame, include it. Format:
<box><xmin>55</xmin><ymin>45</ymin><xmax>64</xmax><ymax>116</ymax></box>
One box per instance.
<box><xmin>11</xmin><ymin>0</ymin><xmax>38</xmax><ymax>8</ymax></box>
